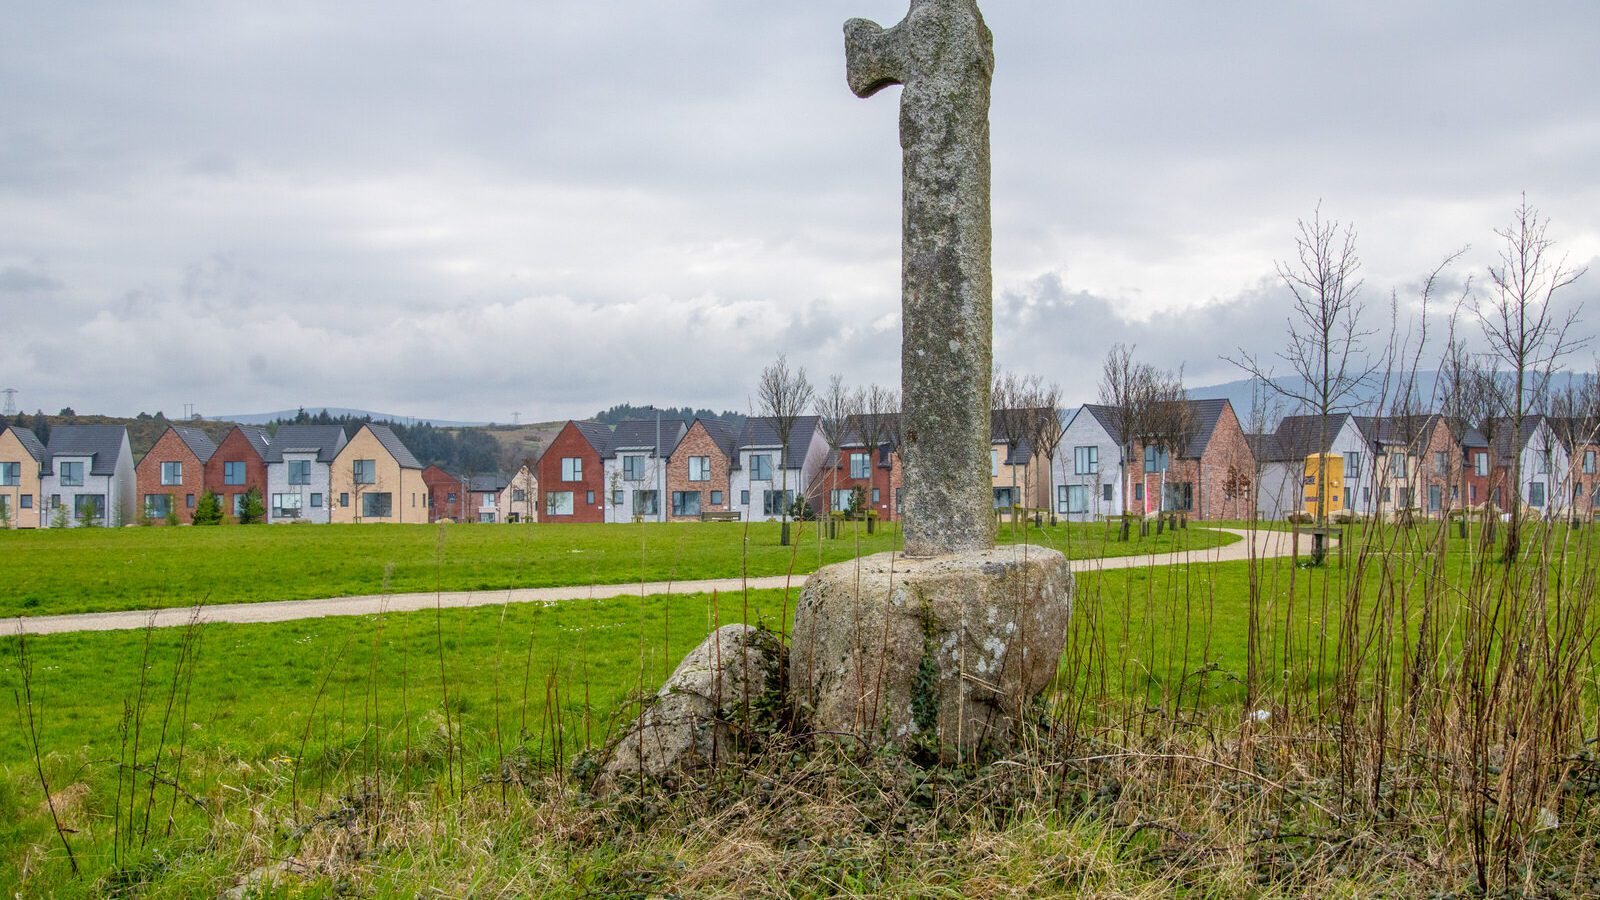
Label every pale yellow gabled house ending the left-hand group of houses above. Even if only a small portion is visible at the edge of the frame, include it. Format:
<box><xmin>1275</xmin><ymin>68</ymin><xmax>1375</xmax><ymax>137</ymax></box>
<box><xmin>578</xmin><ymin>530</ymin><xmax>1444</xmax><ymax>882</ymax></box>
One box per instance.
<box><xmin>328</xmin><ymin>424</ymin><xmax>427</xmax><ymax>525</ymax></box>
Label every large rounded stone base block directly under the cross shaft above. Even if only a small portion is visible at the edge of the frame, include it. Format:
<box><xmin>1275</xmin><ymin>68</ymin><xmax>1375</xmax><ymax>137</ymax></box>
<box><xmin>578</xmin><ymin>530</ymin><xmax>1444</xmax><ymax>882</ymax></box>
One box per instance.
<box><xmin>789</xmin><ymin>544</ymin><xmax>1074</xmax><ymax>759</ymax></box>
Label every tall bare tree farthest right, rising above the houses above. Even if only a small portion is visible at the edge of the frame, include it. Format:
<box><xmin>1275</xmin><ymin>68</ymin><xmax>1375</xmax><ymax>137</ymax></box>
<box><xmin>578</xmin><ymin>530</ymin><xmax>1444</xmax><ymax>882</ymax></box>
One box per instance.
<box><xmin>1475</xmin><ymin>195</ymin><xmax>1589</xmax><ymax>564</ymax></box>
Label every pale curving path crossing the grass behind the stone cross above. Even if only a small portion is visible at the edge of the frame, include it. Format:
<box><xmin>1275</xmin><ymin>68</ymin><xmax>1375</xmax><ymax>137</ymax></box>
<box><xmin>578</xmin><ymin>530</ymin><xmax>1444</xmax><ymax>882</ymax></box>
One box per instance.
<box><xmin>0</xmin><ymin>528</ymin><xmax>1309</xmax><ymax>634</ymax></box>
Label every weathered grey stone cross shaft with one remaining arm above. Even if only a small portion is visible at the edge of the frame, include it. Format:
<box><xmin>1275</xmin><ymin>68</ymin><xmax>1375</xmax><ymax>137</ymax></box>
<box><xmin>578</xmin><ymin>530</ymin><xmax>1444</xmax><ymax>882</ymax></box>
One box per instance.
<box><xmin>845</xmin><ymin>0</ymin><xmax>995</xmax><ymax>556</ymax></box>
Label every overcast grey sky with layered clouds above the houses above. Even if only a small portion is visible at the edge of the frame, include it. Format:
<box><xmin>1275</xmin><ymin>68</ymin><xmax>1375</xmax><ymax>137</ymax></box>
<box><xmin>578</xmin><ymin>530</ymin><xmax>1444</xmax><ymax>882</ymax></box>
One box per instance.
<box><xmin>0</xmin><ymin>0</ymin><xmax>1600</xmax><ymax>421</ymax></box>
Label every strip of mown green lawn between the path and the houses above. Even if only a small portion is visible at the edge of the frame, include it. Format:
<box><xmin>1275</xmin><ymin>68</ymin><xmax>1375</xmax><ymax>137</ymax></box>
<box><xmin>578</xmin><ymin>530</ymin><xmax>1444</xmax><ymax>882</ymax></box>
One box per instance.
<box><xmin>0</xmin><ymin>512</ymin><xmax>1237</xmax><ymax>617</ymax></box>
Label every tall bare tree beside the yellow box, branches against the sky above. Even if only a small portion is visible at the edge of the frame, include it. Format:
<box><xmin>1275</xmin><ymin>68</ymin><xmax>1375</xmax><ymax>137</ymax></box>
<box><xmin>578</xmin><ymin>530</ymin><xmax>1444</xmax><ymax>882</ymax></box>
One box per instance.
<box><xmin>1230</xmin><ymin>205</ymin><xmax>1376</xmax><ymax>522</ymax></box>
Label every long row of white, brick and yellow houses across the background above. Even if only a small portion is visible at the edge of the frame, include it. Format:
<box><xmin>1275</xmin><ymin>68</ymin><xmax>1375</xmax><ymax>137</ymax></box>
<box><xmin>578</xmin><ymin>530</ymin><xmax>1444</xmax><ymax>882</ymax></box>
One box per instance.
<box><xmin>0</xmin><ymin>400</ymin><xmax>1600</xmax><ymax>527</ymax></box>
